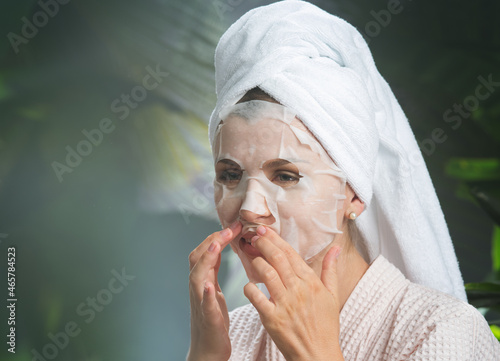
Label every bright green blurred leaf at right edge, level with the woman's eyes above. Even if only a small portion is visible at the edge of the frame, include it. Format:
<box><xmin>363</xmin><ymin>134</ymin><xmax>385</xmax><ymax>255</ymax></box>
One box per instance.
<box><xmin>445</xmin><ymin>158</ymin><xmax>500</xmax><ymax>181</ymax></box>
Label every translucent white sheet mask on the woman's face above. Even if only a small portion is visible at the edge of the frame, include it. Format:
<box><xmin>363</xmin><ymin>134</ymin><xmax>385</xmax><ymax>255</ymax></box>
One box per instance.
<box><xmin>213</xmin><ymin>100</ymin><xmax>346</xmax><ymax>280</ymax></box>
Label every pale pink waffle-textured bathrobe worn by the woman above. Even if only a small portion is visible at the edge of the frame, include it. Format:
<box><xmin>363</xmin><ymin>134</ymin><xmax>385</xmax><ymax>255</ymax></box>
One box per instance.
<box><xmin>229</xmin><ymin>256</ymin><xmax>500</xmax><ymax>361</ymax></box>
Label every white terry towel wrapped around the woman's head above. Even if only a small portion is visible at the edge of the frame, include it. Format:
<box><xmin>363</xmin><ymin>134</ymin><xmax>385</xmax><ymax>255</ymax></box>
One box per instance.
<box><xmin>209</xmin><ymin>0</ymin><xmax>466</xmax><ymax>300</ymax></box>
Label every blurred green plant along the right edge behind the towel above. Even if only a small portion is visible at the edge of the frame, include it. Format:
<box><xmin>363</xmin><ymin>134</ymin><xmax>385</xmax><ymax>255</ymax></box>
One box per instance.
<box><xmin>446</xmin><ymin>158</ymin><xmax>500</xmax><ymax>340</ymax></box>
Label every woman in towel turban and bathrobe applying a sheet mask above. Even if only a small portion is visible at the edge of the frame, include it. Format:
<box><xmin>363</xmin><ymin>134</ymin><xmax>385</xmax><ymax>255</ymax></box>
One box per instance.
<box><xmin>188</xmin><ymin>1</ymin><xmax>500</xmax><ymax>361</ymax></box>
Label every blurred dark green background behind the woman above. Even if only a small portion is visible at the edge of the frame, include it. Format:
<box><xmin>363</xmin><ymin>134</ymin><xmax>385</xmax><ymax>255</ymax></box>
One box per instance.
<box><xmin>0</xmin><ymin>0</ymin><xmax>500</xmax><ymax>361</ymax></box>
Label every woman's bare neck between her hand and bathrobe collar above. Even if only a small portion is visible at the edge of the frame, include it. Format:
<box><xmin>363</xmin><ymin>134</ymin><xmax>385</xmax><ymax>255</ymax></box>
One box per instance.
<box><xmin>309</xmin><ymin>242</ymin><xmax>370</xmax><ymax>309</ymax></box>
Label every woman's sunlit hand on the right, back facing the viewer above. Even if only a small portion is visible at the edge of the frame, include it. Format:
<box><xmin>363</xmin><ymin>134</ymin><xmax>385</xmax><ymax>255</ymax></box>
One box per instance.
<box><xmin>244</xmin><ymin>226</ymin><xmax>343</xmax><ymax>361</ymax></box>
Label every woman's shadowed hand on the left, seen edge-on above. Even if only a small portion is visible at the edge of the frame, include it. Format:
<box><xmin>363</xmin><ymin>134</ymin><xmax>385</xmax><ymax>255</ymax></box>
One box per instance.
<box><xmin>188</xmin><ymin>222</ymin><xmax>241</xmax><ymax>361</ymax></box>
